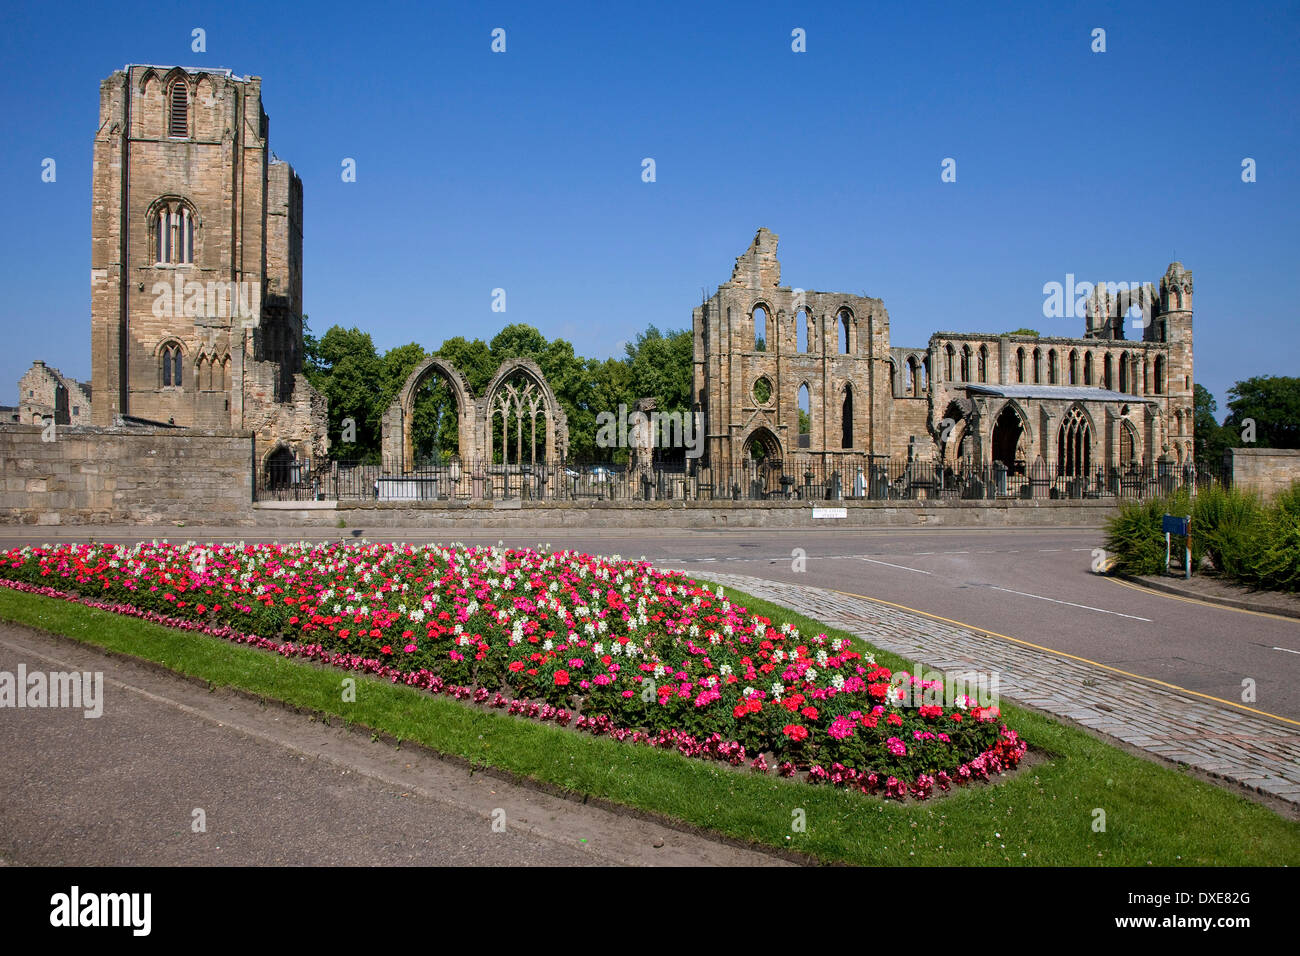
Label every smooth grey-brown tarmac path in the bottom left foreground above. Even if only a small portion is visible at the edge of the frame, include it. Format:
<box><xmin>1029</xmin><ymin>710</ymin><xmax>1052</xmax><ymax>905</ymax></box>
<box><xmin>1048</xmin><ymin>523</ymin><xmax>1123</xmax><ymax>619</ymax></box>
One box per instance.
<box><xmin>0</xmin><ymin>624</ymin><xmax>785</xmax><ymax>866</ymax></box>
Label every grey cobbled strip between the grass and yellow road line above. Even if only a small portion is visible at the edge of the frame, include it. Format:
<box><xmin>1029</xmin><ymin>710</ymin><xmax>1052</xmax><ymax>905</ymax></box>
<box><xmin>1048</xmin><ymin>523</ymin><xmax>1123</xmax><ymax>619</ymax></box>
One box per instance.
<box><xmin>689</xmin><ymin>567</ymin><xmax>1300</xmax><ymax>805</ymax></box>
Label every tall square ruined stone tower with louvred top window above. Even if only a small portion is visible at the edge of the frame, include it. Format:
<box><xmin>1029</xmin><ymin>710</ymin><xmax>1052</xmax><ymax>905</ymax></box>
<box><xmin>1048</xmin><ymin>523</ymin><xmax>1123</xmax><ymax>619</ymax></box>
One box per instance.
<box><xmin>91</xmin><ymin>65</ymin><xmax>328</xmax><ymax>457</ymax></box>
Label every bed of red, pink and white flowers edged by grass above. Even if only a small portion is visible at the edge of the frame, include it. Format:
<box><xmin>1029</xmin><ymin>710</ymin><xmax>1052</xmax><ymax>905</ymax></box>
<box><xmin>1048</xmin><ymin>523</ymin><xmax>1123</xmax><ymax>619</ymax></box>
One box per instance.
<box><xmin>0</xmin><ymin>542</ymin><xmax>1026</xmax><ymax>799</ymax></box>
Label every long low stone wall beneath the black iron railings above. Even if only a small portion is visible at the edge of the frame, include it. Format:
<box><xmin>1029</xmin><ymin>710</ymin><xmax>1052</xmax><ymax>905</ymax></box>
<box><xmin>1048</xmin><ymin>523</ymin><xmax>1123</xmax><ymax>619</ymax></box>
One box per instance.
<box><xmin>252</xmin><ymin>499</ymin><xmax>1115</xmax><ymax>529</ymax></box>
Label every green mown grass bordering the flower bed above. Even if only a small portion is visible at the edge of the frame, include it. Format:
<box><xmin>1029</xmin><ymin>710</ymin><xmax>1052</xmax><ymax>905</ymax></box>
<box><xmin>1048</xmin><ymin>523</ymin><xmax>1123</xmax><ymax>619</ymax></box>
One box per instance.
<box><xmin>0</xmin><ymin>588</ymin><xmax>1300</xmax><ymax>865</ymax></box>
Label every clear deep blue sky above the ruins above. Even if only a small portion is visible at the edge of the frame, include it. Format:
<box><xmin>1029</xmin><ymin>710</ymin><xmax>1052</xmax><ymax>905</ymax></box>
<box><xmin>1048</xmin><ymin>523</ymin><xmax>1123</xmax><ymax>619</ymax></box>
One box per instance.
<box><xmin>0</xmin><ymin>1</ymin><xmax>1300</xmax><ymax>414</ymax></box>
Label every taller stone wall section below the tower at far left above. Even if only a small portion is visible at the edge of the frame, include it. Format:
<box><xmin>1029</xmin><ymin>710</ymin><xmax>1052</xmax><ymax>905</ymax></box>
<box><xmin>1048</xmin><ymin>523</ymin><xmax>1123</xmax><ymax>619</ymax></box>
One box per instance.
<box><xmin>0</xmin><ymin>424</ymin><xmax>254</xmax><ymax>524</ymax></box>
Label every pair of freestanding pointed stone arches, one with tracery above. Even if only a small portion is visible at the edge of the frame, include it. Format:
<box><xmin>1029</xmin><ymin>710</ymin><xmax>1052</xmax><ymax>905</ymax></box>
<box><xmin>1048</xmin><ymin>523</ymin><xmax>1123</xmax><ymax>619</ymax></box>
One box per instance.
<box><xmin>381</xmin><ymin>355</ymin><xmax>568</xmax><ymax>476</ymax></box>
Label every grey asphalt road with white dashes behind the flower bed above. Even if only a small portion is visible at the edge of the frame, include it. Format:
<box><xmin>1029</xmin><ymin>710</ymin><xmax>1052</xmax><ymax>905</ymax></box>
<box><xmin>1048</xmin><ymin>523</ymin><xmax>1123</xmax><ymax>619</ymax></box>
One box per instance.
<box><xmin>0</xmin><ymin>528</ymin><xmax>1300</xmax><ymax>721</ymax></box>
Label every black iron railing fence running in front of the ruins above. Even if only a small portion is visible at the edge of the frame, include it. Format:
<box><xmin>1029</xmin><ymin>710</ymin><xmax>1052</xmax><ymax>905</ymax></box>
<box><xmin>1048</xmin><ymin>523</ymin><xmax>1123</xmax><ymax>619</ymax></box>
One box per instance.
<box><xmin>256</xmin><ymin>455</ymin><xmax>1231</xmax><ymax>502</ymax></box>
